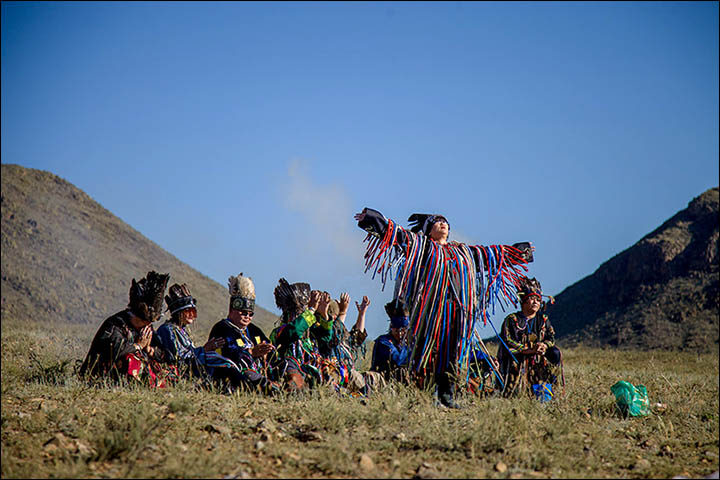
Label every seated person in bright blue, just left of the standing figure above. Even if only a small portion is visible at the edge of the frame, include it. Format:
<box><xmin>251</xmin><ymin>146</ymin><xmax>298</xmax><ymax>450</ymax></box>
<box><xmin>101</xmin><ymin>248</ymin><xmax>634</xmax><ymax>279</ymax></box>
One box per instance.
<box><xmin>370</xmin><ymin>301</ymin><xmax>410</xmax><ymax>381</ymax></box>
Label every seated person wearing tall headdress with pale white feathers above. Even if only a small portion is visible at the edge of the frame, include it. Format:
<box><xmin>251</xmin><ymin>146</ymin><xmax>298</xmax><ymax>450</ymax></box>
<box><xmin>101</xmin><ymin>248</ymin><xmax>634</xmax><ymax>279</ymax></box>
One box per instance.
<box><xmin>208</xmin><ymin>273</ymin><xmax>276</xmax><ymax>392</ymax></box>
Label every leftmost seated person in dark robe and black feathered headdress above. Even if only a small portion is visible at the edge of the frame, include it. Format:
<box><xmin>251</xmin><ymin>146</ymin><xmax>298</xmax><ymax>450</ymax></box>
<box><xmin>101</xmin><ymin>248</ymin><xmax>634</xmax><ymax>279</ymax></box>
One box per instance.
<box><xmin>79</xmin><ymin>271</ymin><xmax>171</xmax><ymax>387</ymax></box>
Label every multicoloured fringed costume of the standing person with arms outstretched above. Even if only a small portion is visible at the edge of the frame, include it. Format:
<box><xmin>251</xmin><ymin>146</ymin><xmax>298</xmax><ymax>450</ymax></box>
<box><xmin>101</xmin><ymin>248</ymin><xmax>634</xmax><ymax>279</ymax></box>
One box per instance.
<box><xmin>358</xmin><ymin>208</ymin><xmax>533</xmax><ymax>404</ymax></box>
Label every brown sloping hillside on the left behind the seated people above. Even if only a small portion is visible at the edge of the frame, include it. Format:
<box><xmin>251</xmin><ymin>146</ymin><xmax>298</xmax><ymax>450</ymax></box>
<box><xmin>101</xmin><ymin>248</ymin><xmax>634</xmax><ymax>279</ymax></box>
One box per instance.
<box><xmin>0</xmin><ymin>164</ymin><xmax>277</xmax><ymax>338</ymax></box>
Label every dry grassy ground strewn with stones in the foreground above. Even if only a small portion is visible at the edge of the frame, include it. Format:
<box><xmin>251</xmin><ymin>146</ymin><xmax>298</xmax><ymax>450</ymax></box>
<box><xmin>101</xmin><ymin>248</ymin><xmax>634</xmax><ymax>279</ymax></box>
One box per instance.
<box><xmin>1</xmin><ymin>320</ymin><xmax>719</xmax><ymax>478</ymax></box>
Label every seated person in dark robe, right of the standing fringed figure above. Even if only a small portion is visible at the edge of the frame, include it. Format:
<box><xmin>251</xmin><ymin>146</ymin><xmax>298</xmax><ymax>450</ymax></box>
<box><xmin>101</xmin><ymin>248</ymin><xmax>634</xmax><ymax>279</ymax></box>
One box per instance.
<box><xmin>498</xmin><ymin>278</ymin><xmax>562</xmax><ymax>396</ymax></box>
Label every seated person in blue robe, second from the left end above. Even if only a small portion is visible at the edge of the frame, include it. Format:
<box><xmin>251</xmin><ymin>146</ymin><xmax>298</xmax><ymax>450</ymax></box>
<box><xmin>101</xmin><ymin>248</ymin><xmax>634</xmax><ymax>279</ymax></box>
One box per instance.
<box><xmin>157</xmin><ymin>283</ymin><xmax>266</xmax><ymax>392</ymax></box>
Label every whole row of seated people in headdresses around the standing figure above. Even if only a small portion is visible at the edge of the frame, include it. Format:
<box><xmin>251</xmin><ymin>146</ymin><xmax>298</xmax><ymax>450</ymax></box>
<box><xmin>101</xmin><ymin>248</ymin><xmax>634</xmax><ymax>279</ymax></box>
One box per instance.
<box><xmin>79</xmin><ymin>271</ymin><xmax>560</xmax><ymax>402</ymax></box>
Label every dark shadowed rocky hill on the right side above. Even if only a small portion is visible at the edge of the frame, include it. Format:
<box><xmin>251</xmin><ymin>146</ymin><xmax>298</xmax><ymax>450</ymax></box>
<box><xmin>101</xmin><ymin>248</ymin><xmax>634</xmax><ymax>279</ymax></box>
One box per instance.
<box><xmin>548</xmin><ymin>187</ymin><xmax>720</xmax><ymax>351</ymax></box>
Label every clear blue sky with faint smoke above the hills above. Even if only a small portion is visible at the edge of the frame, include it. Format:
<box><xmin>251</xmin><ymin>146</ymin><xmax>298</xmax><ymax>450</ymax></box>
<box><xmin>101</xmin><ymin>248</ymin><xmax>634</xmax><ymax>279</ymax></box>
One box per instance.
<box><xmin>1</xmin><ymin>2</ymin><xmax>718</xmax><ymax>337</ymax></box>
